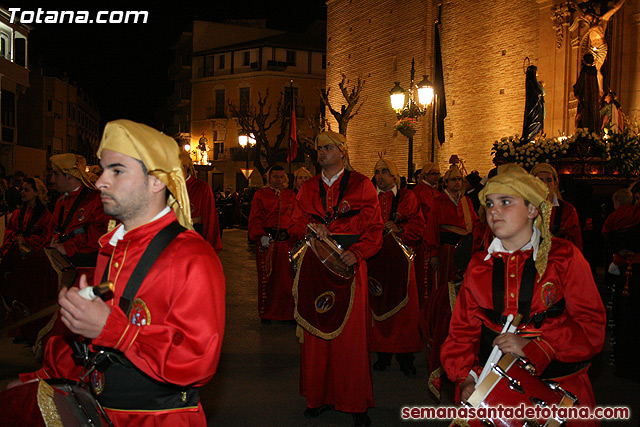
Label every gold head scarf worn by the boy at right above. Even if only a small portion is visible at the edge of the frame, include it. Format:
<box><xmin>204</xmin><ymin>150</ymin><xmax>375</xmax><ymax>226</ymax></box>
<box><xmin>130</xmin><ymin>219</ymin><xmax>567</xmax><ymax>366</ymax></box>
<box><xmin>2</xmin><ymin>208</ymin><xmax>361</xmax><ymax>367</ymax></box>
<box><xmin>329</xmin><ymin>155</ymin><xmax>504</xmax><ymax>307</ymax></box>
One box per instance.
<box><xmin>479</xmin><ymin>172</ymin><xmax>552</xmax><ymax>279</ymax></box>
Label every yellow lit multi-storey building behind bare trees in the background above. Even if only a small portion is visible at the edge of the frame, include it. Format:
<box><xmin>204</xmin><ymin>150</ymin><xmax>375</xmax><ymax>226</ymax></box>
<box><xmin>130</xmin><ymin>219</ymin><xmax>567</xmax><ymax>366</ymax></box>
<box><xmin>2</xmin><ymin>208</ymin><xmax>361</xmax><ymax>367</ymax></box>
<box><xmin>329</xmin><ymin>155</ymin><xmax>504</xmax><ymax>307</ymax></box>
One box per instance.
<box><xmin>185</xmin><ymin>20</ymin><xmax>326</xmax><ymax>191</ymax></box>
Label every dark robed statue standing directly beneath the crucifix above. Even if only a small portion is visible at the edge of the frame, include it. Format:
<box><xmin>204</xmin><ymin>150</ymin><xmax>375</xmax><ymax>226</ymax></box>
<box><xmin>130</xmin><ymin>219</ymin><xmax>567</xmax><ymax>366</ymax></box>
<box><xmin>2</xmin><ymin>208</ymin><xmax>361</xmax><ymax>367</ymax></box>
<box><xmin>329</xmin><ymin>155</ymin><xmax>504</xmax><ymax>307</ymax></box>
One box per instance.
<box><xmin>573</xmin><ymin>53</ymin><xmax>600</xmax><ymax>132</ymax></box>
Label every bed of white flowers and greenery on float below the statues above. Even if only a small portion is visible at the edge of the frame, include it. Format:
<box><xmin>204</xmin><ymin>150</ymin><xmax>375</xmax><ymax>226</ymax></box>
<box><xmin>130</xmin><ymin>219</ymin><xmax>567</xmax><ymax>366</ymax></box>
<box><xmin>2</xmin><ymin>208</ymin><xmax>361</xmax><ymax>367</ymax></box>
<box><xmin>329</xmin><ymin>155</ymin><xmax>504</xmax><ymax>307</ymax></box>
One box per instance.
<box><xmin>491</xmin><ymin>118</ymin><xmax>640</xmax><ymax>175</ymax></box>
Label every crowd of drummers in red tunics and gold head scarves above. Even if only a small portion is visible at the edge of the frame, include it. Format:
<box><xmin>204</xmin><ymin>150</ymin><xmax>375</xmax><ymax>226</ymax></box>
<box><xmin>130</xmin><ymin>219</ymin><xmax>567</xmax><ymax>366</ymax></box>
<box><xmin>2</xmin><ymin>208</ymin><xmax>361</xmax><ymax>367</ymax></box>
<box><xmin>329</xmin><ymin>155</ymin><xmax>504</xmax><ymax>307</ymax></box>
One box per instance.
<box><xmin>0</xmin><ymin>120</ymin><xmax>640</xmax><ymax>426</ymax></box>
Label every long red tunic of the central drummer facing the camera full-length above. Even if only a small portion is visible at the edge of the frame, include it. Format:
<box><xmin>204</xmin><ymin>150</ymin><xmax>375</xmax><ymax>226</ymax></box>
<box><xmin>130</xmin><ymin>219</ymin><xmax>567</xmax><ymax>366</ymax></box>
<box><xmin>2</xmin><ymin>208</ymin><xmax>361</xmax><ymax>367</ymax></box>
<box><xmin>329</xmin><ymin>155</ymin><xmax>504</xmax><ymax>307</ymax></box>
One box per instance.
<box><xmin>290</xmin><ymin>172</ymin><xmax>383</xmax><ymax>412</ymax></box>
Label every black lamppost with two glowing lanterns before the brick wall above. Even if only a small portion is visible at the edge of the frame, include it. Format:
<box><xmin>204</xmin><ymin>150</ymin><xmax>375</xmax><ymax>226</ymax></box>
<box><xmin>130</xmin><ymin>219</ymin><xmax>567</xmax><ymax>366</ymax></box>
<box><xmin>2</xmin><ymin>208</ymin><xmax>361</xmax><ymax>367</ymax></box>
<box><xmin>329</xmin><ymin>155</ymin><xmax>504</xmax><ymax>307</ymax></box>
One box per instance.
<box><xmin>389</xmin><ymin>58</ymin><xmax>433</xmax><ymax>182</ymax></box>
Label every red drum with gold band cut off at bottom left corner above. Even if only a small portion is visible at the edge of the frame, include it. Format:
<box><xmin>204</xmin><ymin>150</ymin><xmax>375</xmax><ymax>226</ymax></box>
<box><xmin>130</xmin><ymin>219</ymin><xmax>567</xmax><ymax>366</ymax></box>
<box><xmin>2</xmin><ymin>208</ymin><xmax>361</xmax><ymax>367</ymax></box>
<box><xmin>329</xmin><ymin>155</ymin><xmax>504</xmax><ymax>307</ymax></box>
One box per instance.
<box><xmin>0</xmin><ymin>379</ymin><xmax>113</xmax><ymax>427</ymax></box>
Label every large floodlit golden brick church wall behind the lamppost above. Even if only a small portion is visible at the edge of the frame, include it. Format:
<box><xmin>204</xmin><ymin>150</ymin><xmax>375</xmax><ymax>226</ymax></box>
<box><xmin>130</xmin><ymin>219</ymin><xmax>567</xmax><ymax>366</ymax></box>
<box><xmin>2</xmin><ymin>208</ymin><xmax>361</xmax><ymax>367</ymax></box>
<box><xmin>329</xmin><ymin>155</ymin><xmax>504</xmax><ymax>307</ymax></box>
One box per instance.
<box><xmin>327</xmin><ymin>0</ymin><xmax>640</xmax><ymax>174</ymax></box>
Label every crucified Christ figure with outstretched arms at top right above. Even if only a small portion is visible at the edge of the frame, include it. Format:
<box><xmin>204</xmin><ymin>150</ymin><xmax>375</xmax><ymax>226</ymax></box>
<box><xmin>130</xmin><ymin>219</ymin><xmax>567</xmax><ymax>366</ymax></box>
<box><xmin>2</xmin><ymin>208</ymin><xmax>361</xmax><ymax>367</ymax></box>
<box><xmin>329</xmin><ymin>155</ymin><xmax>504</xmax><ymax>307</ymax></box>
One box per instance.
<box><xmin>569</xmin><ymin>0</ymin><xmax>625</xmax><ymax>96</ymax></box>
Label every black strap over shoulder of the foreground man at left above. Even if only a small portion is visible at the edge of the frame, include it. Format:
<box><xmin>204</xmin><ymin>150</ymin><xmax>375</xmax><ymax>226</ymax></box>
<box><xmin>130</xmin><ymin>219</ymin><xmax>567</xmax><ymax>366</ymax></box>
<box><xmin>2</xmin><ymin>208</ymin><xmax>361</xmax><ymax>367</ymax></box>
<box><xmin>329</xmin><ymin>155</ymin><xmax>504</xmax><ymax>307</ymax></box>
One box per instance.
<box><xmin>102</xmin><ymin>222</ymin><xmax>186</xmax><ymax>316</ymax></box>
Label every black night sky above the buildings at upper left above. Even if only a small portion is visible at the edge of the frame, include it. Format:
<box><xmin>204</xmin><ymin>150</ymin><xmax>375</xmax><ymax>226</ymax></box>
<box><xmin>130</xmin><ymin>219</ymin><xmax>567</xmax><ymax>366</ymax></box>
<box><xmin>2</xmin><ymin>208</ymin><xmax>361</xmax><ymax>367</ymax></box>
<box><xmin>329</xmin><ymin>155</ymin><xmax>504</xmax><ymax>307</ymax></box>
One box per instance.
<box><xmin>11</xmin><ymin>0</ymin><xmax>326</xmax><ymax>126</ymax></box>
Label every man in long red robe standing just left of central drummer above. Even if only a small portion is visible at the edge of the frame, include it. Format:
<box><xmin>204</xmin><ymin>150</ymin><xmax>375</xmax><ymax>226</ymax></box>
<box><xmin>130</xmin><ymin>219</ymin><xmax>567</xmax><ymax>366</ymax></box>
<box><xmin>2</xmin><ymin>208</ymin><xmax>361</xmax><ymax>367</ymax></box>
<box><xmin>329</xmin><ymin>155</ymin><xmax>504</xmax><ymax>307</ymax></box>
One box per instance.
<box><xmin>249</xmin><ymin>165</ymin><xmax>296</xmax><ymax>323</ymax></box>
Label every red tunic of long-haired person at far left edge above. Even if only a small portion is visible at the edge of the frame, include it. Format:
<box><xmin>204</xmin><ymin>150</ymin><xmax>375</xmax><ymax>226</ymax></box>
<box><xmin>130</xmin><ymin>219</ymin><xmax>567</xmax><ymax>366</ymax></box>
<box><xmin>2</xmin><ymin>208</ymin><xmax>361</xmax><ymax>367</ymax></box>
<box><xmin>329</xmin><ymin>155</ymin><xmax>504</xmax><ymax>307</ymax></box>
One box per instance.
<box><xmin>0</xmin><ymin>206</ymin><xmax>55</xmax><ymax>258</ymax></box>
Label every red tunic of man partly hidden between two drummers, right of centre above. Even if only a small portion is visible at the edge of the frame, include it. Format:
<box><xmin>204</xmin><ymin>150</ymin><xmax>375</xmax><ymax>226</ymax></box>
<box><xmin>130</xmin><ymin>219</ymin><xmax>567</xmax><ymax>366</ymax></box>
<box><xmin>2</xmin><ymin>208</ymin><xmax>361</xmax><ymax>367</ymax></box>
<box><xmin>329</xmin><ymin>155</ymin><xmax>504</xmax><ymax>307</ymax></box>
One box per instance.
<box><xmin>413</xmin><ymin>181</ymin><xmax>440</xmax><ymax>306</ymax></box>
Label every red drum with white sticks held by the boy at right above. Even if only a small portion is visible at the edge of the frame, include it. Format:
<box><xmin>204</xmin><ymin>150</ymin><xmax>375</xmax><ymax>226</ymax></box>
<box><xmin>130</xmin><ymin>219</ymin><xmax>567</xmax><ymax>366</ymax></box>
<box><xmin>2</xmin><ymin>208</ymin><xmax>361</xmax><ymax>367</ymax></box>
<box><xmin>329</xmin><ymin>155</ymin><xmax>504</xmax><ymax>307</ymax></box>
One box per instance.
<box><xmin>454</xmin><ymin>354</ymin><xmax>577</xmax><ymax>427</ymax></box>
